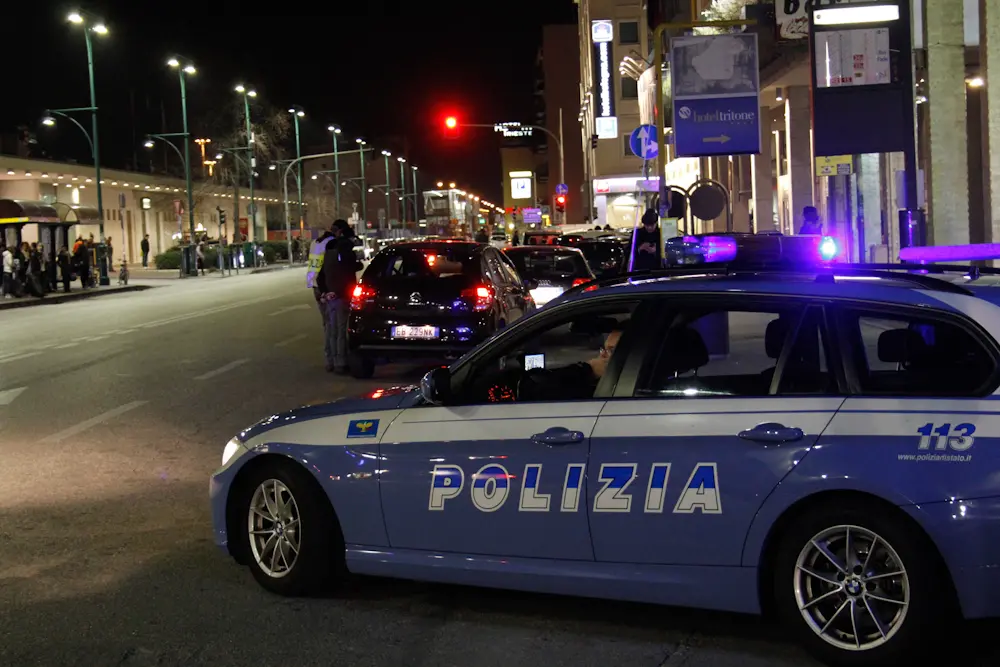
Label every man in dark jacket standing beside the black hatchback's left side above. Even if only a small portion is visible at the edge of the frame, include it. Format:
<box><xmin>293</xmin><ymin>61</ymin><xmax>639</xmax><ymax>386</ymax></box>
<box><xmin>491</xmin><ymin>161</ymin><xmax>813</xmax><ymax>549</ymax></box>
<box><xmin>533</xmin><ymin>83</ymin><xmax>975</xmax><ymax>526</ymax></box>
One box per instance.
<box><xmin>317</xmin><ymin>220</ymin><xmax>360</xmax><ymax>375</ymax></box>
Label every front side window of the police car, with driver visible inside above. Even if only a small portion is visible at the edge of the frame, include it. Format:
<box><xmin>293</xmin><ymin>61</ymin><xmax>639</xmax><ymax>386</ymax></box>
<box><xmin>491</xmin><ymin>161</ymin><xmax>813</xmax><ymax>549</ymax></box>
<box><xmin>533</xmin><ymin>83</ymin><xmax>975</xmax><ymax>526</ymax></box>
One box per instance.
<box><xmin>456</xmin><ymin>302</ymin><xmax>635</xmax><ymax>405</ymax></box>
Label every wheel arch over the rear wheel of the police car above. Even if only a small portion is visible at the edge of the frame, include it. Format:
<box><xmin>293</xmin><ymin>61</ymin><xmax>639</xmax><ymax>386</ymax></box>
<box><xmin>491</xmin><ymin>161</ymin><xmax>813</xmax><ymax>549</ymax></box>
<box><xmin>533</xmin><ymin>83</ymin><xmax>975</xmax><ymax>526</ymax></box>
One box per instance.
<box><xmin>757</xmin><ymin>490</ymin><xmax>960</xmax><ymax>617</ymax></box>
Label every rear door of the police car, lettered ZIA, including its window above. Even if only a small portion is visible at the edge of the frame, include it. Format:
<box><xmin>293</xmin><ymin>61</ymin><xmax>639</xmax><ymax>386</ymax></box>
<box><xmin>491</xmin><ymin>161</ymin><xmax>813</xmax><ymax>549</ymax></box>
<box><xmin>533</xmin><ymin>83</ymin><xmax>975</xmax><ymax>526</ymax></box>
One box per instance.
<box><xmin>587</xmin><ymin>295</ymin><xmax>844</xmax><ymax>566</ymax></box>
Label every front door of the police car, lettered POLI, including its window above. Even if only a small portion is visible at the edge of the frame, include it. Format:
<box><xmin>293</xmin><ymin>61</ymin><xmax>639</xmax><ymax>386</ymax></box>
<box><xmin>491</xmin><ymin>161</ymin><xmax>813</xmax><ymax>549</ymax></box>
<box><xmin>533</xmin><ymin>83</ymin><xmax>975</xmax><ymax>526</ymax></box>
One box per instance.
<box><xmin>380</xmin><ymin>304</ymin><xmax>633</xmax><ymax>560</ymax></box>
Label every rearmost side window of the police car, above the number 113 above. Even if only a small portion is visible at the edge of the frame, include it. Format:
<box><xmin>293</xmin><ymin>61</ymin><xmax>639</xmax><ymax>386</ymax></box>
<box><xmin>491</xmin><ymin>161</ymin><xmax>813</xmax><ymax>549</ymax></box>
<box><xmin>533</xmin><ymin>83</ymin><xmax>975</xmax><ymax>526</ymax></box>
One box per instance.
<box><xmin>840</xmin><ymin>309</ymin><xmax>996</xmax><ymax>396</ymax></box>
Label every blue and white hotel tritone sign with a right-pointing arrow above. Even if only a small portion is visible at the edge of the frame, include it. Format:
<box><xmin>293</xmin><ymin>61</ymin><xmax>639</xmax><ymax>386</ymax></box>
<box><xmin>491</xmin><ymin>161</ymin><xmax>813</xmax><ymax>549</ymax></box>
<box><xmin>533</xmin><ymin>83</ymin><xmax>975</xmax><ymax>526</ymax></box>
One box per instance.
<box><xmin>670</xmin><ymin>34</ymin><xmax>760</xmax><ymax>157</ymax></box>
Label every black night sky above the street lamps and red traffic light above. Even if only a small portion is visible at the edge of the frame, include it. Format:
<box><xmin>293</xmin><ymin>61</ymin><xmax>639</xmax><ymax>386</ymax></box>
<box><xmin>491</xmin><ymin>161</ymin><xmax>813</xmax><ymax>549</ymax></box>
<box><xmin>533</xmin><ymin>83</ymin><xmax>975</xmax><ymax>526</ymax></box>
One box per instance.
<box><xmin>0</xmin><ymin>5</ymin><xmax>576</xmax><ymax>204</ymax></box>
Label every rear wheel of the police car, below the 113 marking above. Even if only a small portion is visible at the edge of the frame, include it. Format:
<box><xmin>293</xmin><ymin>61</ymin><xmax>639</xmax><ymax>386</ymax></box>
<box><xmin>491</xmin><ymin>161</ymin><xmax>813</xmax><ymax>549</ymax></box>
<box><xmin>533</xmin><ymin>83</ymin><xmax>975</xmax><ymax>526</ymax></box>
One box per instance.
<box><xmin>774</xmin><ymin>504</ymin><xmax>957</xmax><ymax>667</ymax></box>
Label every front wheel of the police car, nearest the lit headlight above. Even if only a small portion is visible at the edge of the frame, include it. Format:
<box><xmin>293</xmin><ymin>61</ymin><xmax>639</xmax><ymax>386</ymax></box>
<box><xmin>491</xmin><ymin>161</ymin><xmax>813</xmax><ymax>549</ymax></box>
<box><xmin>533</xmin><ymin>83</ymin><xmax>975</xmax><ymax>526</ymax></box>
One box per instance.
<box><xmin>232</xmin><ymin>459</ymin><xmax>346</xmax><ymax>596</ymax></box>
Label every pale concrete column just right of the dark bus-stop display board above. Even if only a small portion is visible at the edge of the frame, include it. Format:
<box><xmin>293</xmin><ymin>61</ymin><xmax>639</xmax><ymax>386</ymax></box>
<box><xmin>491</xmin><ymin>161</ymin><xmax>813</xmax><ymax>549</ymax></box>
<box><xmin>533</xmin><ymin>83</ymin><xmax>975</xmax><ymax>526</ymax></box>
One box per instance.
<box><xmin>924</xmin><ymin>0</ymin><xmax>969</xmax><ymax>245</ymax></box>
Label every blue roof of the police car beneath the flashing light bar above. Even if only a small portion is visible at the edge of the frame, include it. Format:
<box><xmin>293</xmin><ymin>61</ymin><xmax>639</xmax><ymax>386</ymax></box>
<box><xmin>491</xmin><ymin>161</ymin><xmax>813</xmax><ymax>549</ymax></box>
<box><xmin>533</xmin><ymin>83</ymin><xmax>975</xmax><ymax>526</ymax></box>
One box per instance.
<box><xmin>549</xmin><ymin>265</ymin><xmax>1000</xmax><ymax>311</ymax></box>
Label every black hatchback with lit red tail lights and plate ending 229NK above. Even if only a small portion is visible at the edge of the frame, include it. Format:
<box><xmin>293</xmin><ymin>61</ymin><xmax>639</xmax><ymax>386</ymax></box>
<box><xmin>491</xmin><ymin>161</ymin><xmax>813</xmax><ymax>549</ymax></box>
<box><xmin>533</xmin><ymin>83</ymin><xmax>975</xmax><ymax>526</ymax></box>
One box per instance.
<box><xmin>347</xmin><ymin>241</ymin><xmax>534</xmax><ymax>378</ymax></box>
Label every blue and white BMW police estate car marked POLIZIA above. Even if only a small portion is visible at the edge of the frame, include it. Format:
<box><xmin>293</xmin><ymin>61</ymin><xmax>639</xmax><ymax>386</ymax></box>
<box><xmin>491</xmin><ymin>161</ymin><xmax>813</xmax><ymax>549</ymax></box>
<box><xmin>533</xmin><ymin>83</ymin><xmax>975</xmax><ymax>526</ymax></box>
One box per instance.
<box><xmin>211</xmin><ymin>237</ymin><xmax>1000</xmax><ymax>665</ymax></box>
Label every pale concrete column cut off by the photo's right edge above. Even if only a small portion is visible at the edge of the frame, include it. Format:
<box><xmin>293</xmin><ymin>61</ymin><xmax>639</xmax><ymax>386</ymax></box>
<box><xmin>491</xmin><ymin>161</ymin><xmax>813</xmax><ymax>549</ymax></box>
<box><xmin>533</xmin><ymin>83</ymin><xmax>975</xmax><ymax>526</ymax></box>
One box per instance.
<box><xmin>979</xmin><ymin>0</ymin><xmax>1000</xmax><ymax>243</ymax></box>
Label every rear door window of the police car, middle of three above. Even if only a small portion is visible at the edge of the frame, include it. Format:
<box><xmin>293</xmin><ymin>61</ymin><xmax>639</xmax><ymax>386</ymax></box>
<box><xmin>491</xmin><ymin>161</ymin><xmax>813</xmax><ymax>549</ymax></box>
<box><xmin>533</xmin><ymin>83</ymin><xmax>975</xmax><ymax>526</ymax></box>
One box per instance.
<box><xmin>634</xmin><ymin>306</ymin><xmax>835</xmax><ymax>398</ymax></box>
